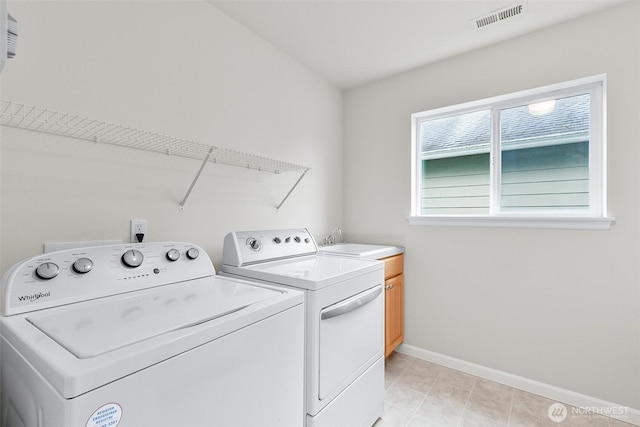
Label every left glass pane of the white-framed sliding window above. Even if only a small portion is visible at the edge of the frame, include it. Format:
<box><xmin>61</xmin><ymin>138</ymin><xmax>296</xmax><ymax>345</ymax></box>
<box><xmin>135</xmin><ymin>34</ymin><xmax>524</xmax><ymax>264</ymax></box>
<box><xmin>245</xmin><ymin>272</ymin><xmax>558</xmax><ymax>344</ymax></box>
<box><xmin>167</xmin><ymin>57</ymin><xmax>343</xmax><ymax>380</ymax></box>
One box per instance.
<box><xmin>419</xmin><ymin>110</ymin><xmax>491</xmax><ymax>215</ymax></box>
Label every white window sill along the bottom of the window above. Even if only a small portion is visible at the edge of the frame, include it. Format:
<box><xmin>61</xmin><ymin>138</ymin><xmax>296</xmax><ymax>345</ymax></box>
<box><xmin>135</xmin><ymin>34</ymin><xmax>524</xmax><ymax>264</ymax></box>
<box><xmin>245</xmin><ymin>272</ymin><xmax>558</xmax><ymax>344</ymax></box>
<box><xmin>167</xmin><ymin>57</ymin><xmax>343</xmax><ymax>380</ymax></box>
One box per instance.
<box><xmin>407</xmin><ymin>216</ymin><xmax>616</xmax><ymax>230</ymax></box>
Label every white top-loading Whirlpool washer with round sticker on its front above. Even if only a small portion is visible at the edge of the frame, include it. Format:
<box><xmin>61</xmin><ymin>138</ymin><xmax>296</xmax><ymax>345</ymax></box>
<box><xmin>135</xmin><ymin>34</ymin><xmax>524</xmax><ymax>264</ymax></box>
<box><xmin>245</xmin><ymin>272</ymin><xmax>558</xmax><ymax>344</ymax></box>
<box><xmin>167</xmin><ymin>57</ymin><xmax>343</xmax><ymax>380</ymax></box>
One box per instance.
<box><xmin>0</xmin><ymin>242</ymin><xmax>304</xmax><ymax>427</ymax></box>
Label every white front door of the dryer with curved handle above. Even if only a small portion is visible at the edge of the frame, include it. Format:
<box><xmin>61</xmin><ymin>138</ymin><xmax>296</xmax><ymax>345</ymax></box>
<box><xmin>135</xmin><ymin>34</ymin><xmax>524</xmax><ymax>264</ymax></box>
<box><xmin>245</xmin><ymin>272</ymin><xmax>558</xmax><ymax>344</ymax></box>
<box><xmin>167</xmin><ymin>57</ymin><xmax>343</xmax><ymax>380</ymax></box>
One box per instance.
<box><xmin>318</xmin><ymin>285</ymin><xmax>384</xmax><ymax>400</ymax></box>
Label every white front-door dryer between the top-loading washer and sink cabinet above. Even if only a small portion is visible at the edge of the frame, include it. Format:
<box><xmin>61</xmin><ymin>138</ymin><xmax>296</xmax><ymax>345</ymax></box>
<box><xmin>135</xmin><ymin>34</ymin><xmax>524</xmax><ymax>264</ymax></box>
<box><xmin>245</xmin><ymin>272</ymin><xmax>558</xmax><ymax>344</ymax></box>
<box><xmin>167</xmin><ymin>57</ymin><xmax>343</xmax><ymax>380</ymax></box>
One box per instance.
<box><xmin>221</xmin><ymin>228</ymin><xmax>384</xmax><ymax>427</ymax></box>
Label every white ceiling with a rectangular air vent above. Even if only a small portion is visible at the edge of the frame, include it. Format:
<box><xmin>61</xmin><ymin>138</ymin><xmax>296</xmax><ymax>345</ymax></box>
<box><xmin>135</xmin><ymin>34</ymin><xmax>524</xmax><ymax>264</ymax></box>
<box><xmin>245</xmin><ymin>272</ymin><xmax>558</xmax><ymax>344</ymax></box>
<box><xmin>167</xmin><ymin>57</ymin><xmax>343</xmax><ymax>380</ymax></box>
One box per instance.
<box><xmin>208</xmin><ymin>0</ymin><xmax>621</xmax><ymax>88</ymax></box>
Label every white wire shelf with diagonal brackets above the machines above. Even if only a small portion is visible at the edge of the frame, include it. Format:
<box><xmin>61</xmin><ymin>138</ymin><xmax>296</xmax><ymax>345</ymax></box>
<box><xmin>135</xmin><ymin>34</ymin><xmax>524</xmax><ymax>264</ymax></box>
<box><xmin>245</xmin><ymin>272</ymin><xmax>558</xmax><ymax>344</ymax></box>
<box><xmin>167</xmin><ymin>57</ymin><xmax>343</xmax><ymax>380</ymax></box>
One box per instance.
<box><xmin>0</xmin><ymin>99</ymin><xmax>311</xmax><ymax>209</ymax></box>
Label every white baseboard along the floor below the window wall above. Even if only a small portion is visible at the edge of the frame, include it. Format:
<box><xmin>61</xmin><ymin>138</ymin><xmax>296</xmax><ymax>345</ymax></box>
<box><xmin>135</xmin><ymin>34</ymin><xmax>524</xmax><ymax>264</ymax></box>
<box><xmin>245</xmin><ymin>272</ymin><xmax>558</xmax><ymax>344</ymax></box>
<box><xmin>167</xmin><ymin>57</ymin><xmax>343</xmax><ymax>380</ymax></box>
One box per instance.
<box><xmin>396</xmin><ymin>344</ymin><xmax>640</xmax><ymax>426</ymax></box>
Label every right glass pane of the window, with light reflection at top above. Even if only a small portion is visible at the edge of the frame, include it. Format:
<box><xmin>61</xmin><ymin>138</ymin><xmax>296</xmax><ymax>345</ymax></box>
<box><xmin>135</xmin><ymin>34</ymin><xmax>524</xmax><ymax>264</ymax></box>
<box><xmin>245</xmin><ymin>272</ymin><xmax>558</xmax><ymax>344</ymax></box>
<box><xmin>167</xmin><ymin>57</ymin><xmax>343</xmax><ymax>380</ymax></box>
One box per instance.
<box><xmin>500</xmin><ymin>94</ymin><xmax>590</xmax><ymax>211</ymax></box>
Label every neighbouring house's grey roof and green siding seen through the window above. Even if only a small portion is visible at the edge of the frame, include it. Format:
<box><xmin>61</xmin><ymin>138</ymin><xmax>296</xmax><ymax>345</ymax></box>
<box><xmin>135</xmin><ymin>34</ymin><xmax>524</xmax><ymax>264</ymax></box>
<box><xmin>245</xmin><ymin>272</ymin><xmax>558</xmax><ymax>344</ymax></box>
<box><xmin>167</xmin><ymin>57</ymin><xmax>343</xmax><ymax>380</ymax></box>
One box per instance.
<box><xmin>418</xmin><ymin>93</ymin><xmax>591</xmax><ymax>215</ymax></box>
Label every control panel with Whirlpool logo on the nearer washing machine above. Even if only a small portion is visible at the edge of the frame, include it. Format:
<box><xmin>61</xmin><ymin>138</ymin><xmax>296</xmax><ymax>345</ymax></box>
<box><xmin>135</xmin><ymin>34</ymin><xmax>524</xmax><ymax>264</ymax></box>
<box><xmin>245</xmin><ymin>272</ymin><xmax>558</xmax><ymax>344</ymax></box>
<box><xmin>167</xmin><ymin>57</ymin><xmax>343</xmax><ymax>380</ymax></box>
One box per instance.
<box><xmin>0</xmin><ymin>242</ymin><xmax>216</xmax><ymax>316</ymax></box>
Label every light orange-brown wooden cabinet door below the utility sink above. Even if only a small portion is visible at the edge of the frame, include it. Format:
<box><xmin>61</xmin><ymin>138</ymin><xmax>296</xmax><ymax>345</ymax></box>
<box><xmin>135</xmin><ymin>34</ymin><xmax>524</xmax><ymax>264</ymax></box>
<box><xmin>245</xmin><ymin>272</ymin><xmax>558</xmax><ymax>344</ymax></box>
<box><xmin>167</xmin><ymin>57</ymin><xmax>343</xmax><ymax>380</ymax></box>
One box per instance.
<box><xmin>384</xmin><ymin>274</ymin><xmax>404</xmax><ymax>357</ymax></box>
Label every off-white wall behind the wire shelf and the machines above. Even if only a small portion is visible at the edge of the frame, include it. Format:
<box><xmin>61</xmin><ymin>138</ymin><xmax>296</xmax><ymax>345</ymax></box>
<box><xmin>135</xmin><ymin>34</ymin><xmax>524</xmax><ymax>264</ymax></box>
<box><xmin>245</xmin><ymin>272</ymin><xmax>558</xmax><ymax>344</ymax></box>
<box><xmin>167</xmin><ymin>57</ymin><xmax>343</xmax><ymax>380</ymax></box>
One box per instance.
<box><xmin>0</xmin><ymin>1</ymin><xmax>342</xmax><ymax>272</ymax></box>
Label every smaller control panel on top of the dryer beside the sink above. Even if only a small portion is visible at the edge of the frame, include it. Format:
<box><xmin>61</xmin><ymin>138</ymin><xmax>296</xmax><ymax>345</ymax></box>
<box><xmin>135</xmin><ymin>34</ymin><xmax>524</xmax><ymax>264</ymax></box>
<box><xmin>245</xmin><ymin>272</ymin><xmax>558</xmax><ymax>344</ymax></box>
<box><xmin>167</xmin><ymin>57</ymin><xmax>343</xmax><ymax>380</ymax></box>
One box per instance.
<box><xmin>222</xmin><ymin>228</ymin><xmax>318</xmax><ymax>267</ymax></box>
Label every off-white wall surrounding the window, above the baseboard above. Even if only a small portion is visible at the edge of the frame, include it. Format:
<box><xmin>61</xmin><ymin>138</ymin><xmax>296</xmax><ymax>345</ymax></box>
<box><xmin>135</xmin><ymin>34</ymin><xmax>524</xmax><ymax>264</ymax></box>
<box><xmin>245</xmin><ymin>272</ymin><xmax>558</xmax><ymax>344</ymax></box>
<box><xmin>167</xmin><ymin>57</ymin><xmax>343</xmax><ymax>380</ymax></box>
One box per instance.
<box><xmin>344</xmin><ymin>2</ymin><xmax>640</xmax><ymax>409</ymax></box>
